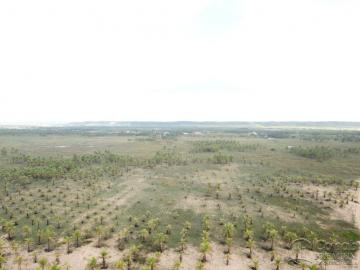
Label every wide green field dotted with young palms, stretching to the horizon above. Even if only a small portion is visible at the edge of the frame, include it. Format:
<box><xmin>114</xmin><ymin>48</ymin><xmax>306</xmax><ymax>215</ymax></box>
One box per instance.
<box><xmin>0</xmin><ymin>128</ymin><xmax>360</xmax><ymax>270</ymax></box>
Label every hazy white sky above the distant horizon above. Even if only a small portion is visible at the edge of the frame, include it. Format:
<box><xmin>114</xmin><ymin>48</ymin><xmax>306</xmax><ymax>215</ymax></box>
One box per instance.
<box><xmin>0</xmin><ymin>0</ymin><xmax>360</xmax><ymax>123</ymax></box>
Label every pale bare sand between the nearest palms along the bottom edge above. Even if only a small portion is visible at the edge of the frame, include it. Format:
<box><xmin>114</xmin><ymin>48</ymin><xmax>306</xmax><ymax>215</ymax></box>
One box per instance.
<box><xmin>0</xmin><ymin>229</ymin><xmax>358</xmax><ymax>270</ymax></box>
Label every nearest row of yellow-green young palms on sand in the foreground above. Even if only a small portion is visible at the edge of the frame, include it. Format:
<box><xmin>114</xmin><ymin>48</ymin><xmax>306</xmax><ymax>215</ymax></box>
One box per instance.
<box><xmin>1</xmin><ymin>187</ymin><xmax>356</xmax><ymax>269</ymax></box>
